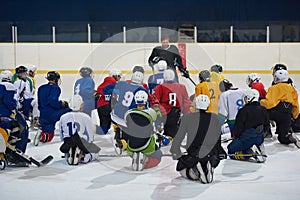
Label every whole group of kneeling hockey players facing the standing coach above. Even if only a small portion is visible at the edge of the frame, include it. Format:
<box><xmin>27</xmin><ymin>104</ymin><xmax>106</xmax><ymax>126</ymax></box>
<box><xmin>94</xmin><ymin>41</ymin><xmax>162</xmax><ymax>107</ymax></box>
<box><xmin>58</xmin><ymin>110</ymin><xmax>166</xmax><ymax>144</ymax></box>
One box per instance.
<box><xmin>0</xmin><ymin>60</ymin><xmax>300</xmax><ymax>183</ymax></box>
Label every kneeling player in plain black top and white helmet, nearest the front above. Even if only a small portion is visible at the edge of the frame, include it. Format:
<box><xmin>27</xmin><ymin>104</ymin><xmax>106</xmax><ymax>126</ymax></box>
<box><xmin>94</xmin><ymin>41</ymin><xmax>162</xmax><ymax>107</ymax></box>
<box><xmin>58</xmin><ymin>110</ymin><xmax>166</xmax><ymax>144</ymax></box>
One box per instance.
<box><xmin>170</xmin><ymin>94</ymin><xmax>221</xmax><ymax>183</ymax></box>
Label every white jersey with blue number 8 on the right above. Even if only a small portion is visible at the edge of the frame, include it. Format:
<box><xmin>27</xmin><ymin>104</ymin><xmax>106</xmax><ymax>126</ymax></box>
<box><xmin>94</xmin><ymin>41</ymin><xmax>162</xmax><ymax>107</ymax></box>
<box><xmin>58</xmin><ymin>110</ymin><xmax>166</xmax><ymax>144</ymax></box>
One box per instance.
<box><xmin>218</xmin><ymin>88</ymin><xmax>244</xmax><ymax>121</ymax></box>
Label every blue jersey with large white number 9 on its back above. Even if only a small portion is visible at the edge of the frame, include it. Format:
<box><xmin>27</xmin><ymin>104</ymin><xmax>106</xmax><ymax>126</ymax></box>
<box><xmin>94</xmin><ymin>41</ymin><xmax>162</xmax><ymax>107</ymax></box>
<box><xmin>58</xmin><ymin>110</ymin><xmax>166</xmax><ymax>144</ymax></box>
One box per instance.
<box><xmin>111</xmin><ymin>81</ymin><xmax>148</xmax><ymax>126</ymax></box>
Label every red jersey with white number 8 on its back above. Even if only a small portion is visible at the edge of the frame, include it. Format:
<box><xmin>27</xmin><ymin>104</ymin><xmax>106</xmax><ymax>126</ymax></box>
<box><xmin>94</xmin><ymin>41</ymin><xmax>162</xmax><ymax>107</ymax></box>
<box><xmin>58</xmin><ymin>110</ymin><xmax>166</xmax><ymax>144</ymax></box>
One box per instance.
<box><xmin>152</xmin><ymin>83</ymin><xmax>191</xmax><ymax>115</ymax></box>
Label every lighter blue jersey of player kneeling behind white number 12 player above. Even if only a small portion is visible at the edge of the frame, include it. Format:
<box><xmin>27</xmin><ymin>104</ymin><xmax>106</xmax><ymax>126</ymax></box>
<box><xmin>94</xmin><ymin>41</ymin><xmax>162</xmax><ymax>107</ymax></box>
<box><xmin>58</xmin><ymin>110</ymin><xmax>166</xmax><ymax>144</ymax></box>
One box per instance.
<box><xmin>74</xmin><ymin>77</ymin><xmax>95</xmax><ymax>115</ymax></box>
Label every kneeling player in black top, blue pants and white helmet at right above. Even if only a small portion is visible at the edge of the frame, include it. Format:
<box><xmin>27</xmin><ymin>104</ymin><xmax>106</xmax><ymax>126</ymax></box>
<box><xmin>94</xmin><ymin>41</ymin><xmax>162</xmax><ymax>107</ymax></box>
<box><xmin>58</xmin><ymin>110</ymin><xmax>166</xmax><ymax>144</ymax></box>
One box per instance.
<box><xmin>227</xmin><ymin>89</ymin><xmax>269</xmax><ymax>163</ymax></box>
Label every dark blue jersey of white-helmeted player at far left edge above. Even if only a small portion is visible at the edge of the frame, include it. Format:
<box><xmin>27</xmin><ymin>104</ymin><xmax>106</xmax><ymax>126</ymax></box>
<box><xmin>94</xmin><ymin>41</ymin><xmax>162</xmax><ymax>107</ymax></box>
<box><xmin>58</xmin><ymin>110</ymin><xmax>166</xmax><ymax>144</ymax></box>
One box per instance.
<box><xmin>0</xmin><ymin>82</ymin><xmax>17</xmax><ymax>117</ymax></box>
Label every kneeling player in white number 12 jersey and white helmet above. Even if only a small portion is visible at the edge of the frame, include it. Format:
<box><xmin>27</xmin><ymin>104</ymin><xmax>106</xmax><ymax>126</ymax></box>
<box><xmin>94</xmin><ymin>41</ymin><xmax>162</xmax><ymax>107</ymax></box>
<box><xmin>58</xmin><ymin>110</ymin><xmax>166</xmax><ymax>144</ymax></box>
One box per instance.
<box><xmin>59</xmin><ymin>95</ymin><xmax>100</xmax><ymax>165</ymax></box>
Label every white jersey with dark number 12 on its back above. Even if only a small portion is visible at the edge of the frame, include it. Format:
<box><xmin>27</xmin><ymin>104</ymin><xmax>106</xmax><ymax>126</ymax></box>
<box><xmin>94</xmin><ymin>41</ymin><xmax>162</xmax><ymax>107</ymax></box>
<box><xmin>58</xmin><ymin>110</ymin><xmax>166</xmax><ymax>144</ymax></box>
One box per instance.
<box><xmin>59</xmin><ymin>112</ymin><xmax>94</xmax><ymax>142</ymax></box>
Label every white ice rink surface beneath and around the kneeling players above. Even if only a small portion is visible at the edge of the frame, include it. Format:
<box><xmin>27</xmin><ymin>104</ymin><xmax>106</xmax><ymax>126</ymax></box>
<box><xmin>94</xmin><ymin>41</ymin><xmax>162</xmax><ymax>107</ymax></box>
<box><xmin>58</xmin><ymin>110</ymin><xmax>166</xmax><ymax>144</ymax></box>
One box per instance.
<box><xmin>0</xmin><ymin>72</ymin><xmax>300</xmax><ymax>200</ymax></box>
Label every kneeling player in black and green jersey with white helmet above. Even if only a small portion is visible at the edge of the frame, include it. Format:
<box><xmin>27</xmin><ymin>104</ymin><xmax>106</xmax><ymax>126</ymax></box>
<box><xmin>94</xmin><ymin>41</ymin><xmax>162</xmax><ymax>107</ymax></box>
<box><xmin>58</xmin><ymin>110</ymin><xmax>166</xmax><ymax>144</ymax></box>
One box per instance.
<box><xmin>122</xmin><ymin>90</ymin><xmax>162</xmax><ymax>171</ymax></box>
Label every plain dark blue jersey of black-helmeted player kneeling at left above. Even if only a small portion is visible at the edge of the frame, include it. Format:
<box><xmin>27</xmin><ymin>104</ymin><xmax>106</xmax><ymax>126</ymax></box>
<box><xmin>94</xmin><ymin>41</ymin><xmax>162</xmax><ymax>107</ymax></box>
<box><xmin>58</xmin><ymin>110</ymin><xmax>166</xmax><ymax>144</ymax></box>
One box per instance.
<box><xmin>38</xmin><ymin>84</ymin><xmax>61</xmax><ymax>118</ymax></box>
